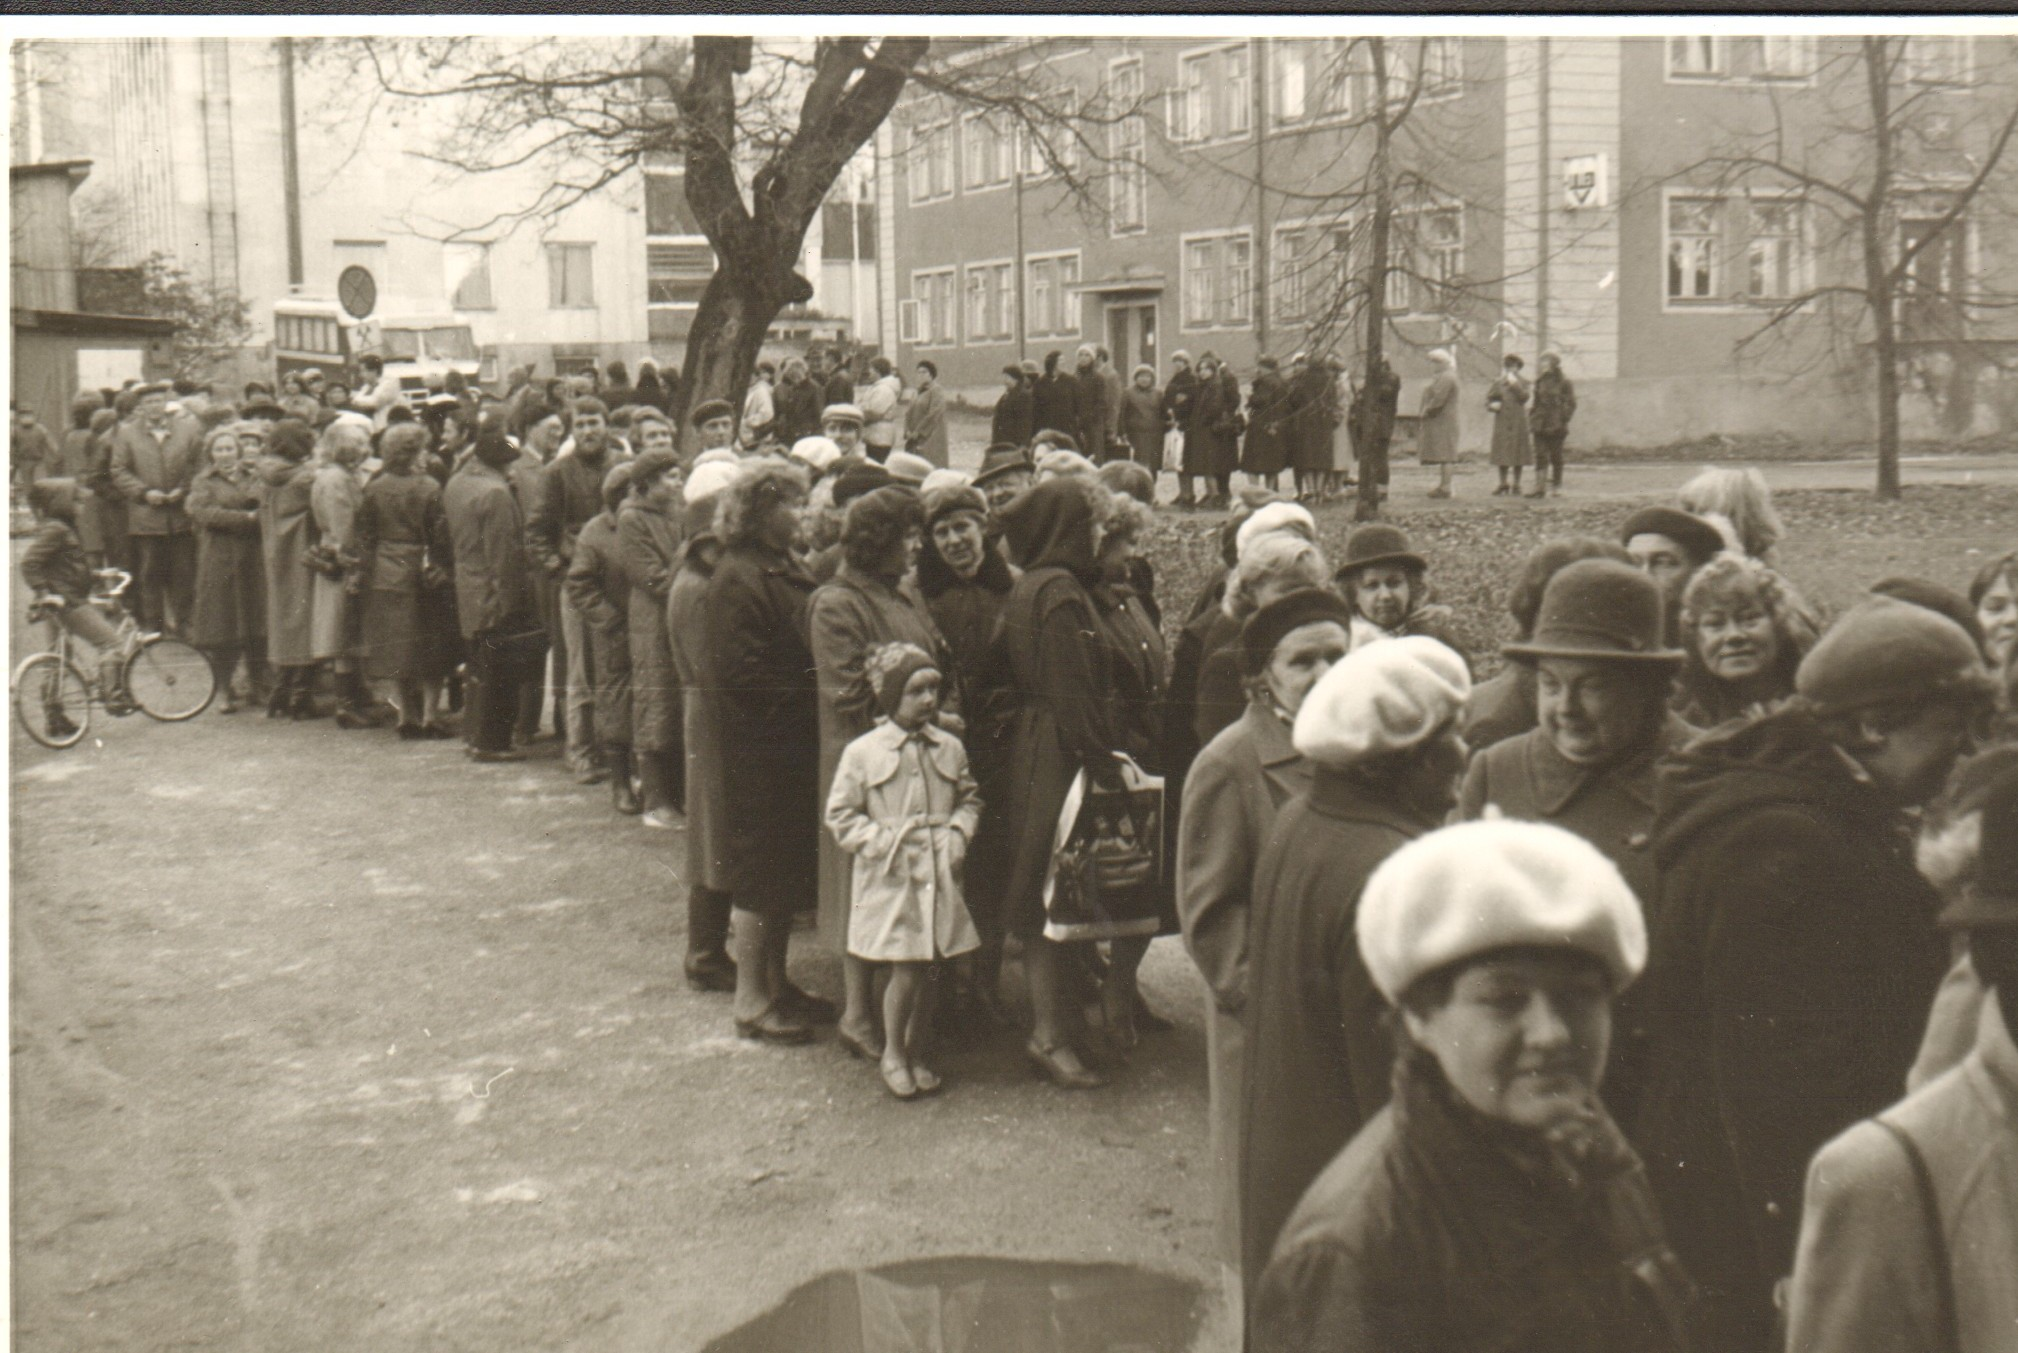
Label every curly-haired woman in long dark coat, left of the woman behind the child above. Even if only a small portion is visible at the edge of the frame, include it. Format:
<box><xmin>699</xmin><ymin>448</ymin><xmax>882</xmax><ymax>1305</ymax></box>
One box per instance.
<box><xmin>704</xmin><ymin>460</ymin><xmax>831</xmax><ymax>1044</ymax></box>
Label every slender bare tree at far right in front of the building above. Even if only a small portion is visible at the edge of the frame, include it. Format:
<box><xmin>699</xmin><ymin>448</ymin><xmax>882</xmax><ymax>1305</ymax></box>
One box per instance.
<box><xmin>1669</xmin><ymin>34</ymin><xmax>2018</xmax><ymax>499</ymax></box>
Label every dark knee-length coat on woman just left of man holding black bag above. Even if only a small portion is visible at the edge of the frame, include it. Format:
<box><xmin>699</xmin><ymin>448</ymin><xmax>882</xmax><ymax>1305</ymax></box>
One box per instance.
<box><xmin>357</xmin><ymin>471</ymin><xmax>456</xmax><ymax>681</ymax></box>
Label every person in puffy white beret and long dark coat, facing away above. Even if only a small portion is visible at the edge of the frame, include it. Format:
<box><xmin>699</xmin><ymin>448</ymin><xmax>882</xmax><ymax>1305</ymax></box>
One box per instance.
<box><xmin>1239</xmin><ymin>636</ymin><xmax>1471</xmax><ymax>1294</ymax></box>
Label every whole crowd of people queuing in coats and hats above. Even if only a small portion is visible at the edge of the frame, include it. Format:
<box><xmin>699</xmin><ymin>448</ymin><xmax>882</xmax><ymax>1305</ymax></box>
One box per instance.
<box><xmin>16</xmin><ymin>347</ymin><xmax>2018</xmax><ymax>1351</ymax></box>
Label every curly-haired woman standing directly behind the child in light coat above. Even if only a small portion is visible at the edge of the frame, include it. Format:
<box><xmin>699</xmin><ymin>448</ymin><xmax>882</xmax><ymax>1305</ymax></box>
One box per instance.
<box><xmin>807</xmin><ymin>487</ymin><xmax>959</xmax><ymax>1060</ymax></box>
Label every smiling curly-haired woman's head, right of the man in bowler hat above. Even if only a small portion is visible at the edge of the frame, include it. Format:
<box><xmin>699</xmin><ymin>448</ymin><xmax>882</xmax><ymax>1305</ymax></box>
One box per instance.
<box><xmin>1673</xmin><ymin>553</ymin><xmax>1820</xmax><ymax>729</ymax></box>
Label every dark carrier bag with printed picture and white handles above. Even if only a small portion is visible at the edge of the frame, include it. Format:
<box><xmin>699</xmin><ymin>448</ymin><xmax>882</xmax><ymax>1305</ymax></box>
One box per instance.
<box><xmin>1043</xmin><ymin>753</ymin><xmax>1164</xmax><ymax>941</ymax></box>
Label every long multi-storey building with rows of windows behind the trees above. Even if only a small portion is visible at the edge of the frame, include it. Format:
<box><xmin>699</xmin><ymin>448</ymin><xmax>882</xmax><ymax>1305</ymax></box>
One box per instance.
<box><xmin>880</xmin><ymin>34</ymin><xmax>2018</xmax><ymax>446</ymax></box>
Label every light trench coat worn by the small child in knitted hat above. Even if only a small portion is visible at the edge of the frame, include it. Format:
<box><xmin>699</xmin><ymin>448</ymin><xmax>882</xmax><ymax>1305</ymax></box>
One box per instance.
<box><xmin>827</xmin><ymin>721</ymin><xmax>981</xmax><ymax>963</ymax></box>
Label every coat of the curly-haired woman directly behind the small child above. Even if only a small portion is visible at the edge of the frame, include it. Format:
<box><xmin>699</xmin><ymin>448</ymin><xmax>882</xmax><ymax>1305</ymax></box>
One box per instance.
<box><xmin>807</xmin><ymin>563</ymin><xmax>959</xmax><ymax>943</ymax></box>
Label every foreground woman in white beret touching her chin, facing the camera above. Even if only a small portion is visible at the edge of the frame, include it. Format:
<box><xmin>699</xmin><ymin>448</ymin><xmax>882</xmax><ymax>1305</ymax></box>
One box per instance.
<box><xmin>1249</xmin><ymin>815</ymin><xmax>1693</xmax><ymax>1353</ymax></box>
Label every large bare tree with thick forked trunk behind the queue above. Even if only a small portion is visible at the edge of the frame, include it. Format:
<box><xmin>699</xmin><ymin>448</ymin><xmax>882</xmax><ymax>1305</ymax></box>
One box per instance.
<box><xmin>309</xmin><ymin>36</ymin><xmax>1130</xmax><ymax>432</ymax></box>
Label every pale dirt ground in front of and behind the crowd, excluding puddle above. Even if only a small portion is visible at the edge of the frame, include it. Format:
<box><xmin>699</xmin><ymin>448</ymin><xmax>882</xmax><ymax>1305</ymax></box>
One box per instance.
<box><xmin>8</xmin><ymin>460</ymin><xmax>2018</xmax><ymax>1353</ymax></box>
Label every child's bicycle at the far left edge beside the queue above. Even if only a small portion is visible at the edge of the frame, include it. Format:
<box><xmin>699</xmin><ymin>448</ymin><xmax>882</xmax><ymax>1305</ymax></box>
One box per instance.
<box><xmin>12</xmin><ymin>569</ymin><xmax>218</xmax><ymax>751</ymax></box>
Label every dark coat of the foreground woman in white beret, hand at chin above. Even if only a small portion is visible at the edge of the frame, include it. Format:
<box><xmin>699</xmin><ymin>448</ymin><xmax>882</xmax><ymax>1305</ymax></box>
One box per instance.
<box><xmin>1247</xmin><ymin>1052</ymin><xmax>1691</xmax><ymax>1353</ymax></box>
